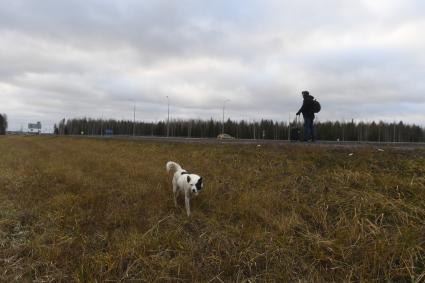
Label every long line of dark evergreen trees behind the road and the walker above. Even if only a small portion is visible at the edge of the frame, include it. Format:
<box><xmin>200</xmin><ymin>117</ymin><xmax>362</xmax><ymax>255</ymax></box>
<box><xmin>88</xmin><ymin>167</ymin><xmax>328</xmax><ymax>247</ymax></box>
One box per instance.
<box><xmin>54</xmin><ymin>118</ymin><xmax>425</xmax><ymax>142</ymax></box>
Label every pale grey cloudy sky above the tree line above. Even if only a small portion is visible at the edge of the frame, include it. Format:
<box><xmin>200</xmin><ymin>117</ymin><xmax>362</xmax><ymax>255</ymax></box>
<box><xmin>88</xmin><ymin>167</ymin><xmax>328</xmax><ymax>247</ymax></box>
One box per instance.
<box><xmin>0</xmin><ymin>0</ymin><xmax>425</xmax><ymax>130</ymax></box>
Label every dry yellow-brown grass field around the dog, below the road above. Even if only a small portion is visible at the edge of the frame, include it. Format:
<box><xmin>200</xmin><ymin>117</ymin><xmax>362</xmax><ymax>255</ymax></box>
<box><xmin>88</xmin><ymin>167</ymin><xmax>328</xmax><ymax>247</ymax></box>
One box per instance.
<box><xmin>0</xmin><ymin>137</ymin><xmax>425</xmax><ymax>282</ymax></box>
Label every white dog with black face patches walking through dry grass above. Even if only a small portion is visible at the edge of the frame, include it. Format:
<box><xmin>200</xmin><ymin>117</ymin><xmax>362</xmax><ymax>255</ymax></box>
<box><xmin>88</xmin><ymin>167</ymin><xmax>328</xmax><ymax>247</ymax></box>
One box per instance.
<box><xmin>165</xmin><ymin>161</ymin><xmax>204</xmax><ymax>216</ymax></box>
